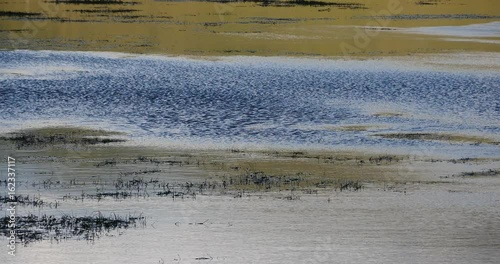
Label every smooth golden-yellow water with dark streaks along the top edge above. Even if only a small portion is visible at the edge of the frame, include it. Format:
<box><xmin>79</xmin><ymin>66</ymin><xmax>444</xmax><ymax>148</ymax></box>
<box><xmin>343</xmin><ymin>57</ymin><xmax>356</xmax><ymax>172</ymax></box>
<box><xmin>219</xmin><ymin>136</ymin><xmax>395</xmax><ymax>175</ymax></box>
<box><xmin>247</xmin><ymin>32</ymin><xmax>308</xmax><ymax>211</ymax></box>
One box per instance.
<box><xmin>0</xmin><ymin>0</ymin><xmax>500</xmax><ymax>56</ymax></box>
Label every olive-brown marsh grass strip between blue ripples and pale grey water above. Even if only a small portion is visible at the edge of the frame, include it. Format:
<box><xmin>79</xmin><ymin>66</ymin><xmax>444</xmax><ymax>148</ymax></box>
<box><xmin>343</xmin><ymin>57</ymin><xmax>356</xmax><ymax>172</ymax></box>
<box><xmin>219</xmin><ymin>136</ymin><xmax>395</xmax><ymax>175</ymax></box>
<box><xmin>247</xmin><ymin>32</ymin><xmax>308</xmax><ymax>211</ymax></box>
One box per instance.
<box><xmin>0</xmin><ymin>127</ymin><xmax>472</xmax><ymax>201</ymax></box>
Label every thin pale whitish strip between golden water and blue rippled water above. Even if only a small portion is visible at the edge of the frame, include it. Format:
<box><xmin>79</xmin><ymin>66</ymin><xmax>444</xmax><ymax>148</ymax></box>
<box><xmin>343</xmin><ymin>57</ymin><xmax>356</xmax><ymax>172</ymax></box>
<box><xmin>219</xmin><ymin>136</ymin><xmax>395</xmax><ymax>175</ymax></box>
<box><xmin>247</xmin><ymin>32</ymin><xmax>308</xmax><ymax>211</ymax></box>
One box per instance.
<box><xmin>0</xmin><ymin>49</ymin><xmax>500</xmax><ymax>77</ymax></box>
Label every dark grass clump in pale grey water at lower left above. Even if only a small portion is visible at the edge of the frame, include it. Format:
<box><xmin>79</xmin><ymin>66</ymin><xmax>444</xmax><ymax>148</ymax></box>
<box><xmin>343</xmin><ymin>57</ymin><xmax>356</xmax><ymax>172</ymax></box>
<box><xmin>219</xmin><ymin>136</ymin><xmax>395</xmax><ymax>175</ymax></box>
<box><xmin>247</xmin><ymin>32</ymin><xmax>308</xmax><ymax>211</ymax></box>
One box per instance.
<box><xmin>0</xmin><ymin>212</ymin><xmax>146</xmax><ymax>245</ymax></box>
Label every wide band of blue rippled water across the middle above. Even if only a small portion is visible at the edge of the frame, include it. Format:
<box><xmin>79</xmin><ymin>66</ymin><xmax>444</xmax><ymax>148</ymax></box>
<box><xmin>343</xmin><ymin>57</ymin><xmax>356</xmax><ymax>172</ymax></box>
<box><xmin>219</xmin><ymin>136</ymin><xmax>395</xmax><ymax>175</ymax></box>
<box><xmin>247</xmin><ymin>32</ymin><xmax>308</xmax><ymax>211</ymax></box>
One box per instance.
<box><xmin>0</xmin><ymin>51</ymin><xmax>500</xmax><ymax>157</ymax></box>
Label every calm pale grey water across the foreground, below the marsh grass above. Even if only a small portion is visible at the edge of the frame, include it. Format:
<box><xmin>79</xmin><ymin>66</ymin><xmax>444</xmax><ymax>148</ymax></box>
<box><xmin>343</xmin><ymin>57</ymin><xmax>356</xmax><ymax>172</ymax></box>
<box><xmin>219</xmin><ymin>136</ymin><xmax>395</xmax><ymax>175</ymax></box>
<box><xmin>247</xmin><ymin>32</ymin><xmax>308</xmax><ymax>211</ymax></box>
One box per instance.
<box><xmin>0</xmin><ymin>181</ymin><xmax>500</xmax><ymax>263</ymax></box>
